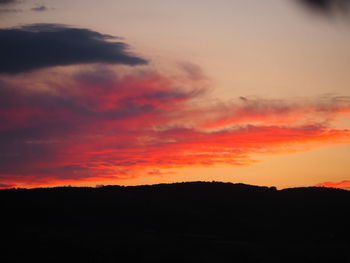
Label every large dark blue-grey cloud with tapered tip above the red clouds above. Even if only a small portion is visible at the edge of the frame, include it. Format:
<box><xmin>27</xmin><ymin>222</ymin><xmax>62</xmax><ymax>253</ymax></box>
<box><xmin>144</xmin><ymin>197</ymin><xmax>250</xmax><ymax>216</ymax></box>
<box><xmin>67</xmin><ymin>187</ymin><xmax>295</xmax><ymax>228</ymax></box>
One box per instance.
<box><xmin>0</xmin><ymin>24</ymin><xmax>147</xmax><ymax>74</ymax></box>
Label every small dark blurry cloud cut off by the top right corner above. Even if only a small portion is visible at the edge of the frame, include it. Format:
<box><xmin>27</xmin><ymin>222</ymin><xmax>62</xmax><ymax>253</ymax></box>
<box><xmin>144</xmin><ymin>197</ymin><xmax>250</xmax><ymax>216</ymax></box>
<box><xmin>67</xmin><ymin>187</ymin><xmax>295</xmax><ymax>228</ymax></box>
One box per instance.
<box><xmin>297</xmin><ymin>0</ymin><xmax>350</xmax><ymax>14</ymax></box>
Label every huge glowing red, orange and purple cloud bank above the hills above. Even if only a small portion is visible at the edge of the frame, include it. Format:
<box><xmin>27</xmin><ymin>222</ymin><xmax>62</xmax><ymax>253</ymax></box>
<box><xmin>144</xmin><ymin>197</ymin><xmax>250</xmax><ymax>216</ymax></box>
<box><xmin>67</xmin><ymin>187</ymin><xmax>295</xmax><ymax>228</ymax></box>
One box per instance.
<box><xmin>0</xmin><ymin>66</ymin><xmax>350</xmax><ymax>189</ymax></box>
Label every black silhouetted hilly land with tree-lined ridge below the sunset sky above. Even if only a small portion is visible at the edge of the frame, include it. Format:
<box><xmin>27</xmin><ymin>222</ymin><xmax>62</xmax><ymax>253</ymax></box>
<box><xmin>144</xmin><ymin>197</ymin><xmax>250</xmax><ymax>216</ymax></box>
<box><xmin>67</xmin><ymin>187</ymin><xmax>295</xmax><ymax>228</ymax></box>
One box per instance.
<box><xmin>0</xmin><ymin>182</ymin><xmax>350</xmax><ymax>262</ymax></box>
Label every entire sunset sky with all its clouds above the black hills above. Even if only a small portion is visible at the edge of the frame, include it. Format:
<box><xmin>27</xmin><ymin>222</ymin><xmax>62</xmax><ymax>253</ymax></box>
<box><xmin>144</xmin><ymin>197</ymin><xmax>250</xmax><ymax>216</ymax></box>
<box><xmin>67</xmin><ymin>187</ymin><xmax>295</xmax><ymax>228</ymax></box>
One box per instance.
<box><xmin>0</xmin><ymin>0</ymin><xmax>350</xmax><ymax>189</ymax></box>
